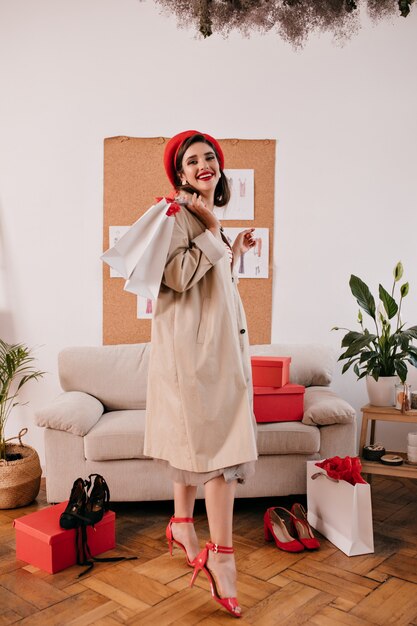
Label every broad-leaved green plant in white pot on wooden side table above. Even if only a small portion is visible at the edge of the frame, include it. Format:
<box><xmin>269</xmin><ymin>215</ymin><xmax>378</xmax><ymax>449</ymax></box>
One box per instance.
<box><xmin>332</xmin><ymin>262</ymin><xmax>417</xmax><ymax>405</ymax></box>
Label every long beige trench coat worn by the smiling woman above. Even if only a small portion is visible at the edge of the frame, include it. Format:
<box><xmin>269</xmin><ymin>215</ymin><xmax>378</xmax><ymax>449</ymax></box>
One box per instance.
<box><xmin>144</xmin><ymin>208</ymin><xmax>257</xmax><ymax>472</ymax></box>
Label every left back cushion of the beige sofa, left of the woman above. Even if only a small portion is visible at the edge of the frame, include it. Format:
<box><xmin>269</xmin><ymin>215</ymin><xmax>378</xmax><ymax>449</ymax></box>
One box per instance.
<box><xmin>58</xmin><ymin>343</ymin><xmax>150</xmax><ymax>411</ymax></box>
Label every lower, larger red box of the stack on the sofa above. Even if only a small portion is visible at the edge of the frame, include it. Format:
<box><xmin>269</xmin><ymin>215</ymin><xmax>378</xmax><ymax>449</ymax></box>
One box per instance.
<box><xmin>253</xmin><ymin>384</ymin><xmax>305</xmax><ymax>422</ymax></box>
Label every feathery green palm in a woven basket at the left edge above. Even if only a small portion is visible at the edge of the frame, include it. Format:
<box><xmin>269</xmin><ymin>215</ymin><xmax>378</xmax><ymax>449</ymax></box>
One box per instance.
<box><xmin>0</xmin><ymin>339</ymin><xmax>44</xmax><ymax>509</ymax></box>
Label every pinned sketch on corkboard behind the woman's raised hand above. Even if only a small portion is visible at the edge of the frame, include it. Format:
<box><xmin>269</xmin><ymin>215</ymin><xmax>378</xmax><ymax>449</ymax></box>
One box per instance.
<box><xmin>223</xmin><ymin>227</ymin><xmax>269</xmax><ymax>278</ymax></box>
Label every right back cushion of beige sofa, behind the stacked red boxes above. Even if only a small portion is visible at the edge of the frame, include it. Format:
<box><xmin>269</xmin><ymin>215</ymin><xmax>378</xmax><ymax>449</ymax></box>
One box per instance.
<box><xmin>250</xmin><ymin>343</ymin><xmax>336</xmax><ymax>387</ymax></box>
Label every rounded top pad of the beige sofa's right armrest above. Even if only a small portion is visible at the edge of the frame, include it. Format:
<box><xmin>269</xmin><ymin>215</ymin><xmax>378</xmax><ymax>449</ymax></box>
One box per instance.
<box><xmin>303</xmin><ymin>387</ymin><xmax>356</xmax><ymax>426</ymax></box>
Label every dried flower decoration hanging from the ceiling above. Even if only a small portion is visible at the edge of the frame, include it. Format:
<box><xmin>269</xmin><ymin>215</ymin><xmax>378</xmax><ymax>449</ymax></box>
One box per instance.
<box><xmin>156</xmin><ymin>0</ymin><xmax>414</xmax><ymax>47</ymax></box>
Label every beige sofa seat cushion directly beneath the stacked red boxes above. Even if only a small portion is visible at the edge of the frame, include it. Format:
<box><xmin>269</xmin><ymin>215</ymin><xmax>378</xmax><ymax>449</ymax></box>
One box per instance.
<box><xmin>258</xmin><ymin>422</ymin><xmax>320</xmax><ymax>455</ymax></box>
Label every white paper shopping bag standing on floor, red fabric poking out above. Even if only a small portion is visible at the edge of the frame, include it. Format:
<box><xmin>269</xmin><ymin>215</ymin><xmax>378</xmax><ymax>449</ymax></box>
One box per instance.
<box><xmin>307</xmin><ymin>461</ymin><xmax>374</xmax><ymax>556</ymax></box>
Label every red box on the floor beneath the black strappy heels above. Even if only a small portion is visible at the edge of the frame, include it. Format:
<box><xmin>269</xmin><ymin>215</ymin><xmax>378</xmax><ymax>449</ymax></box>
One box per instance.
<box><xmin>13</xmin><ymin>501</ymin><xmax>116</xmax><ymax>574</ymax></box>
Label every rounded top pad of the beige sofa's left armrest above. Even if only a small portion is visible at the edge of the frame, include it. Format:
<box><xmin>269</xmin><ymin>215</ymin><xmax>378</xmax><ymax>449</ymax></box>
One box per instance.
<box><xmin>35</xmin><ymin>391</ymin><xmax>104</xmax><ymax>437</ymax></box>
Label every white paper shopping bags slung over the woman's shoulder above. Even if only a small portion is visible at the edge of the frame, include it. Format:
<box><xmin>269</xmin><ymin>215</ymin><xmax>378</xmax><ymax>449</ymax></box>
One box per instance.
<box><xmin>100</xmin><ymin>198</ymin><xmax>180</xmax><ymax>300</ymax></box>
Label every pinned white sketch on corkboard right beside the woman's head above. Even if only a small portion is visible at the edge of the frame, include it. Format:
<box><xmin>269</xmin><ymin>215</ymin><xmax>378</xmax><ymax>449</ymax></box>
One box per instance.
<box><xmin>214</xmin><ymin>170</ymin><xmax>255</xmax><ymax>220</ymax></box>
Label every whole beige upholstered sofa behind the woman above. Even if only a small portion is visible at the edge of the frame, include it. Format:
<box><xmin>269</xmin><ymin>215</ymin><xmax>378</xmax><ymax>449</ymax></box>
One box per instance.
<box><xmin>36</xmin><ymin>343</ymin><xmax>356</xmax><ymax>502</ymax></box>
